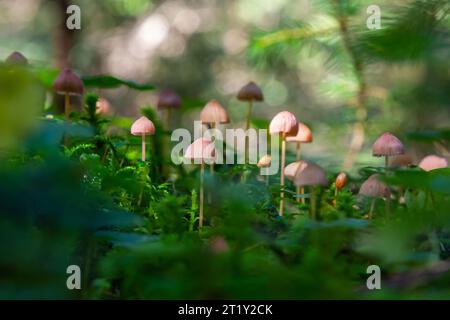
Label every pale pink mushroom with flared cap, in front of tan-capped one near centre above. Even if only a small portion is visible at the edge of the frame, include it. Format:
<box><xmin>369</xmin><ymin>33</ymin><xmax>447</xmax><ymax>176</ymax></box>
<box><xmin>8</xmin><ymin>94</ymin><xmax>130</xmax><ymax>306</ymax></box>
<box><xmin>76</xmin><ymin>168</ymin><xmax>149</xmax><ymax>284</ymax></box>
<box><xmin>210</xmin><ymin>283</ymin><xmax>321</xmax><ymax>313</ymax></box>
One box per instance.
<box><xmin>184</xmin><ymin>138</ymin><xmax>216</xmax><ymax>229</ymax></box>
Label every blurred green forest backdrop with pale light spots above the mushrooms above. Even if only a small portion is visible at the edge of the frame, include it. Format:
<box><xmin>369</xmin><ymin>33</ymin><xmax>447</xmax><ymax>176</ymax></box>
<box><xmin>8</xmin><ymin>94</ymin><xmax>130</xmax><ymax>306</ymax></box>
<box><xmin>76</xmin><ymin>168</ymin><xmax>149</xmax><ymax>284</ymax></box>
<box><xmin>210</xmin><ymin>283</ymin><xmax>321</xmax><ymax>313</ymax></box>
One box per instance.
<box><xmin>0</xmin><ymin>0</ymin><xmax>450</xmax><ymax>169</ymax></box>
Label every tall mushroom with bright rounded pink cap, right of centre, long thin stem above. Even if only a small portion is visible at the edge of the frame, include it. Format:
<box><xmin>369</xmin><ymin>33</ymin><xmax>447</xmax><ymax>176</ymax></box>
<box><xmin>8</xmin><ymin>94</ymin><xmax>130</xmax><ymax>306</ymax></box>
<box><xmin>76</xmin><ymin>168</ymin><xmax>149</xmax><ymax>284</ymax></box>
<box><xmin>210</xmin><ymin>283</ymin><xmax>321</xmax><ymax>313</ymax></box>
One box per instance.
<box><xmin>269</xmin><ymin>111</ymin><xmax>298</xmax><ymax>216</ymax></box>
